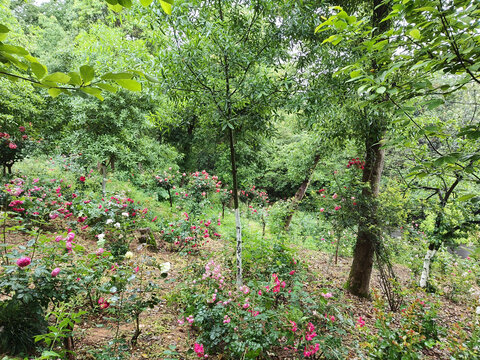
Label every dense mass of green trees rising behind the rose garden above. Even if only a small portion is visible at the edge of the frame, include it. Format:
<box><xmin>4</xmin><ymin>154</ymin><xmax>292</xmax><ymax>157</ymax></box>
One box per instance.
<box><xmin>0</xmin><ymin>0</ymin><xmax>480</xmax><ymax>296</ymax></box>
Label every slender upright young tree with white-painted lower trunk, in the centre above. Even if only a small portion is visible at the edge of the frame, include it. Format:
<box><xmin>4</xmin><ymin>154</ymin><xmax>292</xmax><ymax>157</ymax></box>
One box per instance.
<box><xmin>150</xmin><ymin>1</ymin><xmax>285</xmax><ymax>286</ymax></box>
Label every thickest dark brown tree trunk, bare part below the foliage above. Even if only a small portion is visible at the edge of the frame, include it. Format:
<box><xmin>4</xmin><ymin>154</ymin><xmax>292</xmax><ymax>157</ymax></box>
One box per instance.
<box><xmin>347</xmin><ymin>131</ymin><xmax>385</xmax><ymax>297</ymax></box>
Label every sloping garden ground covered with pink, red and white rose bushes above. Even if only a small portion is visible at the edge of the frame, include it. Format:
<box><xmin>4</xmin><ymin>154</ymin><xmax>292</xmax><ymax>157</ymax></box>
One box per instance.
<box><xmin>1</xmin><ymin>155</ymin><xmax>480</xmax><ymax>359</ymax></box>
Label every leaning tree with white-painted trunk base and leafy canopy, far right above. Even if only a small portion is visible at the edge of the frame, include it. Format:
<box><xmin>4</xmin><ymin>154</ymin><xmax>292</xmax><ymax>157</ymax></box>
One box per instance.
<box><xmin>317</xmin><ymin>1</ymin><xmax>479</xmax><ymax>292</ymax></box>
